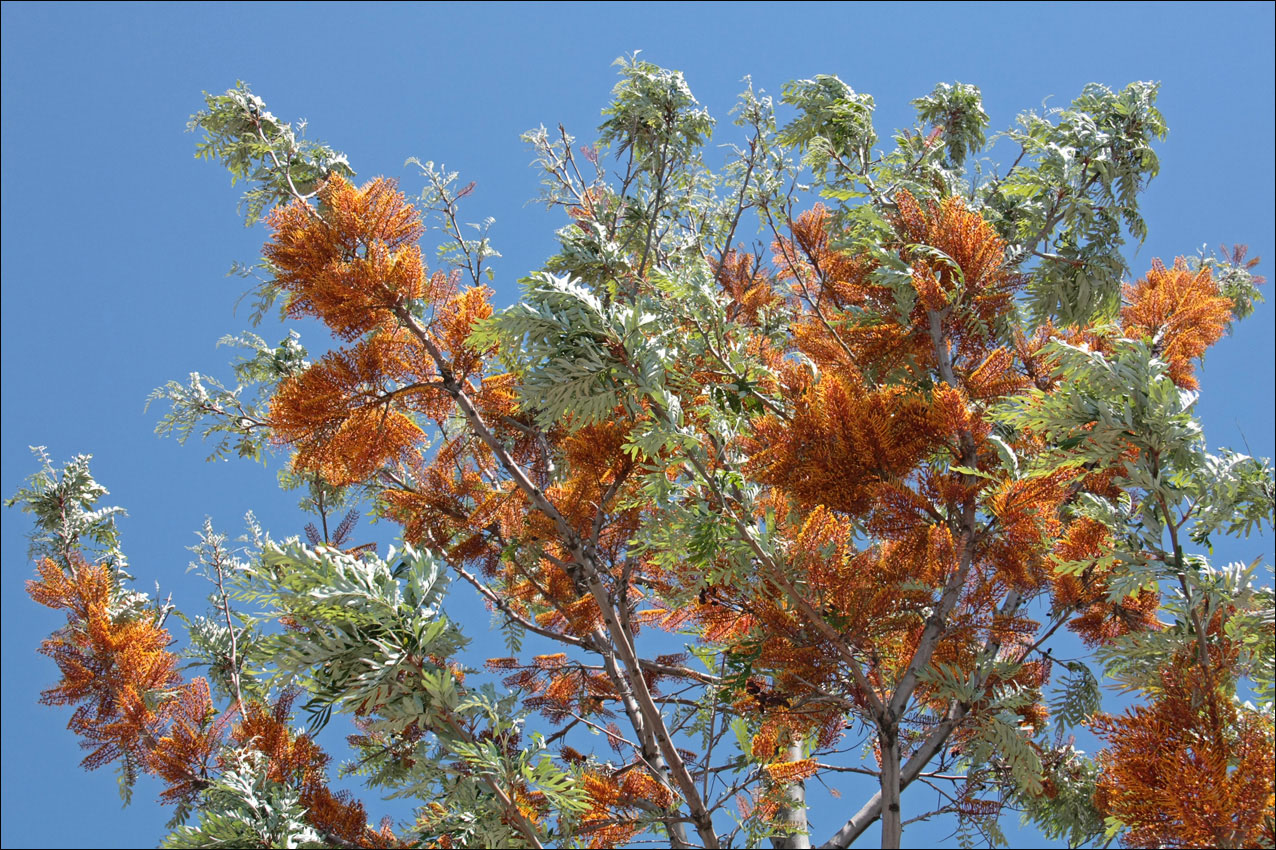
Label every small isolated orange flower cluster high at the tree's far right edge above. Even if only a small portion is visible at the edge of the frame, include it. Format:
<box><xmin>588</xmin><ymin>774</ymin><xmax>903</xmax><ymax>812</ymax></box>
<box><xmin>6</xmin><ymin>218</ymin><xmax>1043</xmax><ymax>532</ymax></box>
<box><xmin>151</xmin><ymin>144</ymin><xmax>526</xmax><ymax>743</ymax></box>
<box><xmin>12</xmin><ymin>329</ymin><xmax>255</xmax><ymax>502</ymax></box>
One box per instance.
<box><xmin>1120</xmin><ymin>257</ymin><xmax>1231</xmax><ymax>389</ymax></box>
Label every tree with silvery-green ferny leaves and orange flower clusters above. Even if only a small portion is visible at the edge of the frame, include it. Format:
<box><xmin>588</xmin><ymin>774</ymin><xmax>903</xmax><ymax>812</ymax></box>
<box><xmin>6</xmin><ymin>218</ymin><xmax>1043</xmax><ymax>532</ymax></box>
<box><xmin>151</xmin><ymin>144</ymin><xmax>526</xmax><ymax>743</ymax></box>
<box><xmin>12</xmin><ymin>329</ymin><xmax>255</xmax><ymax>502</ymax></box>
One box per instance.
<box><xmin>11</xmin><ymin>57</ymin><xmax>1276</xmax><ymax>847</ymax></box>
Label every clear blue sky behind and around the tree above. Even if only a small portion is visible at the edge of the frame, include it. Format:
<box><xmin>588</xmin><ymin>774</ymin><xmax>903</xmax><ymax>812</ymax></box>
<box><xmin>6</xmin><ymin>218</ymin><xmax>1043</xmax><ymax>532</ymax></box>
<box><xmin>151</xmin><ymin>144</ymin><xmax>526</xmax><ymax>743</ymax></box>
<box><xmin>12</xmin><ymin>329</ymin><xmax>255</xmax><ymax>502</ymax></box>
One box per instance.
<box><xmin>0</xmin><ymin>3</ymin><xmax>1276</xmax><ymax>847</ymax></box>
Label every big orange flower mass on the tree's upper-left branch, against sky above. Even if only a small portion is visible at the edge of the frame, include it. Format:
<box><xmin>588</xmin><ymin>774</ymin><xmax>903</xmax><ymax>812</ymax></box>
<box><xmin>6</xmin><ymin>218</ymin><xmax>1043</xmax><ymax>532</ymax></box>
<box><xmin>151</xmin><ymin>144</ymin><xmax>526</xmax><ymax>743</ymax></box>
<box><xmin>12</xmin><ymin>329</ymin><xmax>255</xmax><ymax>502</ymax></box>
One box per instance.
<box><xmin>265</xmin><ymin>176</ymin><xmax>513</xmax><ymax>485</ymax></box>
